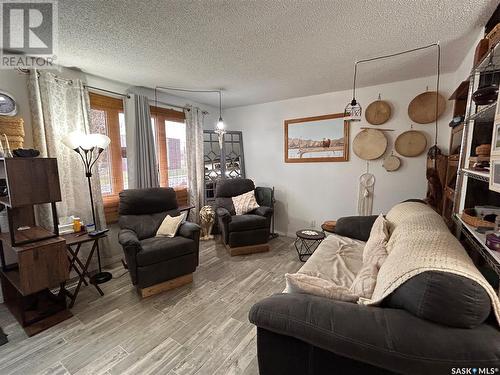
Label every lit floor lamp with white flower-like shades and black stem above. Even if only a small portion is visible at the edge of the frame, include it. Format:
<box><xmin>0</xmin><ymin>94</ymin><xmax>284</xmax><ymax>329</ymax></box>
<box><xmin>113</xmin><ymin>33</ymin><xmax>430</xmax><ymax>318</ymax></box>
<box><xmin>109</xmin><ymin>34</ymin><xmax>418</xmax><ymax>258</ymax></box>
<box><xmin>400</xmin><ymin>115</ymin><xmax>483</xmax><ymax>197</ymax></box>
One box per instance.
<box><xmin>62</xmin><ymin>132</ymin><xmax>113</xmax><ymax>284</ymax></box>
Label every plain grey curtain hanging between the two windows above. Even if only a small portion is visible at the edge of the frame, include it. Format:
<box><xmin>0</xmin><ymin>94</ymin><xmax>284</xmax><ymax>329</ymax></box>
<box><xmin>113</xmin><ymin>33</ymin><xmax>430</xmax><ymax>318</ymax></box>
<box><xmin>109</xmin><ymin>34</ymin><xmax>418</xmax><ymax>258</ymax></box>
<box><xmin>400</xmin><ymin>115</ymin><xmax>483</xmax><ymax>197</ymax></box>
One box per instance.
<box><xmin>125</xmin><ymin>94</ymin><xmax>160</xmax><ymax>188</ymax></box>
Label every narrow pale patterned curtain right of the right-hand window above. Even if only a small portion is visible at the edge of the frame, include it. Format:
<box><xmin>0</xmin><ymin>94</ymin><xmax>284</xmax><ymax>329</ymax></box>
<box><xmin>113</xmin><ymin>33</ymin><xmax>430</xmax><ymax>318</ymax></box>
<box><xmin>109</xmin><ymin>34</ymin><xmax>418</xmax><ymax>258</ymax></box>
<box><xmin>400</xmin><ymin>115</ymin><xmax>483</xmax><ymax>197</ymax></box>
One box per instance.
<box><xmin>184</xmin><ymin>107</ymin><xmax>205</xmax><ymax>223</ymax></box>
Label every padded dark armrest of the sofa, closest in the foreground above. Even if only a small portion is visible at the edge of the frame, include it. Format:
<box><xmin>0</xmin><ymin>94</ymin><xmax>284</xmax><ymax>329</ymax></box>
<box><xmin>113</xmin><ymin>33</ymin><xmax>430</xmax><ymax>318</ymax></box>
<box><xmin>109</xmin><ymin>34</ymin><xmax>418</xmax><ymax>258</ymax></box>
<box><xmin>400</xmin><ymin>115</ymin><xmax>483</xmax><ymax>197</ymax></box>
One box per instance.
<box><xmin>249</xmin><ymin>294</ymin><xmax>500</xmax><ymax>374</ymax></box>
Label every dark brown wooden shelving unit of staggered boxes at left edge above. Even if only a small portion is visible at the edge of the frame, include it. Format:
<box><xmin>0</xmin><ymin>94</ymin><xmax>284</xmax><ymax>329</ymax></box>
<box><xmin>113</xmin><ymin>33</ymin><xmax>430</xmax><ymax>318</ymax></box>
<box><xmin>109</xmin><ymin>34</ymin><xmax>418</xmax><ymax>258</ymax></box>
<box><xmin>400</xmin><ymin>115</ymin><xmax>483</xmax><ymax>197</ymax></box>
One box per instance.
<box><xmin>0</xmin><ymin>158</ymin><xmax>72</xmax><ymax>336</ymax></box>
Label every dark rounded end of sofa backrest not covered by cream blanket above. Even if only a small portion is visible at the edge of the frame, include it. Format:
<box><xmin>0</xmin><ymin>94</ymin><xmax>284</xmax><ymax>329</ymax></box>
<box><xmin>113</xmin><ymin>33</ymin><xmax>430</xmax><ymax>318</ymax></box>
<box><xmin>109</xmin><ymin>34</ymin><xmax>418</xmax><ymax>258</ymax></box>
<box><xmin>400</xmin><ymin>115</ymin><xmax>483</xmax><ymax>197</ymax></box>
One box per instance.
<box><xmin>385</xmin><ymin>271</ymin><xmax>491</xmax><ymax>328</ymax></box>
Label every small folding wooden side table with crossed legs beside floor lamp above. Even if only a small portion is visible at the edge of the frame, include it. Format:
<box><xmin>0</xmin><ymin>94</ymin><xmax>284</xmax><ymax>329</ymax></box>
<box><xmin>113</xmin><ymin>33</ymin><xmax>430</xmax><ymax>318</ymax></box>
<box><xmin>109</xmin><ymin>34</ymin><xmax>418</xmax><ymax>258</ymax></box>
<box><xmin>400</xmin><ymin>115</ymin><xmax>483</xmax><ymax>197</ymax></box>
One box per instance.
<box><xmin>61</xmin><ymin>233</ymin><xmax>107</xmax><ymax>308</ymax></box>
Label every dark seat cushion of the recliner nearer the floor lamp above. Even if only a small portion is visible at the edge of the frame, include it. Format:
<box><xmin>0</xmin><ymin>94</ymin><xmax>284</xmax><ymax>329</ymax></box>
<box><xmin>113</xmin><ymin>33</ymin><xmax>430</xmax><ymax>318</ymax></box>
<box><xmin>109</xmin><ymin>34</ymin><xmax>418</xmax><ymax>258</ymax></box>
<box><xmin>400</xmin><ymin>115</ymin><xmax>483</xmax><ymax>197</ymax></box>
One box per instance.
<box><xmin>136</xmin><ymin>236</ymin><xmax>196</xmax><ymax>266</ymax></box>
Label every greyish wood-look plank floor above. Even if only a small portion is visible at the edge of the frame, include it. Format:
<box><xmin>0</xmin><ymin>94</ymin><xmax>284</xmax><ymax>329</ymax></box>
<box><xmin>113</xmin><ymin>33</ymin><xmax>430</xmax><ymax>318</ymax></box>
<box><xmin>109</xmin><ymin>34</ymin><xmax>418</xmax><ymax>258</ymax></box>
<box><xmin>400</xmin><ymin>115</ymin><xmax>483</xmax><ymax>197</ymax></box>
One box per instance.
<box><xmin>0</xmin><ymin>237</ymin><xmax>302</xmax><ymax>375</ymax></box>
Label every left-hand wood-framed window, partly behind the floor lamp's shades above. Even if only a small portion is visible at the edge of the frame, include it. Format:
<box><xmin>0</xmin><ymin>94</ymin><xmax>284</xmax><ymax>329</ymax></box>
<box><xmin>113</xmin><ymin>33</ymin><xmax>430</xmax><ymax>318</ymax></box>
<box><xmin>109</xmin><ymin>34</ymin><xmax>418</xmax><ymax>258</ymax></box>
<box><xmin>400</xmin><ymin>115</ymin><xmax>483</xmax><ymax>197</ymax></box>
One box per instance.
<box><xmin>90</xmin><ymin>93</ymin><xmax>128</xmax><ymax>222</ymax></box>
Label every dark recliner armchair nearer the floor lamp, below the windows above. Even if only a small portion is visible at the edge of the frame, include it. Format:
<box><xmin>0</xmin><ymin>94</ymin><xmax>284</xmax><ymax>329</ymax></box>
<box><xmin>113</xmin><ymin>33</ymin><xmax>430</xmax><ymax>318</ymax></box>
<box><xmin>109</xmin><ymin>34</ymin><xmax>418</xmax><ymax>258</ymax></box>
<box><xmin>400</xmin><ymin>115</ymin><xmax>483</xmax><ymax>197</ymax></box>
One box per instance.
<box><xmin>118</xmin><ymin>188</ymin><xmax>200</xmax><ymax>296</ymax></box>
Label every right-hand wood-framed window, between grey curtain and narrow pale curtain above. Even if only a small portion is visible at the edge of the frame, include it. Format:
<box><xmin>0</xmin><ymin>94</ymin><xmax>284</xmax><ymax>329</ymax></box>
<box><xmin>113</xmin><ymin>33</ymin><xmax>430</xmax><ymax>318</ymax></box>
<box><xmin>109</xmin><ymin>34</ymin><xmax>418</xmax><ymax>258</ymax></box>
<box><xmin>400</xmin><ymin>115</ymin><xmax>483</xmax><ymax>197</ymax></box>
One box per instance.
<box><xmin>151</xmin><ymin>107</ymin><xmax>188</xmax><ymax>187</ymax></box>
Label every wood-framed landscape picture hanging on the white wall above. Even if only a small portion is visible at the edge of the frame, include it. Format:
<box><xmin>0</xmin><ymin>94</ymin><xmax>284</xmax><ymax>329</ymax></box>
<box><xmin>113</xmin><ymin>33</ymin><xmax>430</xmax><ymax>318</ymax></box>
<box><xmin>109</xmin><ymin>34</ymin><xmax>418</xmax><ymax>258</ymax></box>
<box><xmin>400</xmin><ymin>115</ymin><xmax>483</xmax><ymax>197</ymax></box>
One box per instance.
<box><xmin>285</xmin><ymin>113</ymin><xmax>349</xmax><ymax>163</ymax></box>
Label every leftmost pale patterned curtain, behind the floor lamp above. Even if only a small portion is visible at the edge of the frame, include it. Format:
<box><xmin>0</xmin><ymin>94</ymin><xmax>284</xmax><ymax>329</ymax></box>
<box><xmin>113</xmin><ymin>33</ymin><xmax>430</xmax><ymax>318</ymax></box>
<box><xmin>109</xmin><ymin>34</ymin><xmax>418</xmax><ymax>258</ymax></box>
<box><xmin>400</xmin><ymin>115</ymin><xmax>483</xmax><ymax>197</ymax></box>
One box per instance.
<box><xmin>28</xmin><ymin>70</ymin><xmax>110</xmax><ymax>256</ymax></box>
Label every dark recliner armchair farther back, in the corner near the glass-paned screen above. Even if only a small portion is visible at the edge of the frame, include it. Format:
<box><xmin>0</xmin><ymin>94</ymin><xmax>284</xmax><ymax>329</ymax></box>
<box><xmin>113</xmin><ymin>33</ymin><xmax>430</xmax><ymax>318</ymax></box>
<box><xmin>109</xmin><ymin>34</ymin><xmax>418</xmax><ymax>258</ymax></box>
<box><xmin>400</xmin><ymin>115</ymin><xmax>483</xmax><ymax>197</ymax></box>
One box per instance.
<box><xmin>215</xmin><ymin>178</ymin><xmax>273</xmax><ymax>255</ymax></box>
